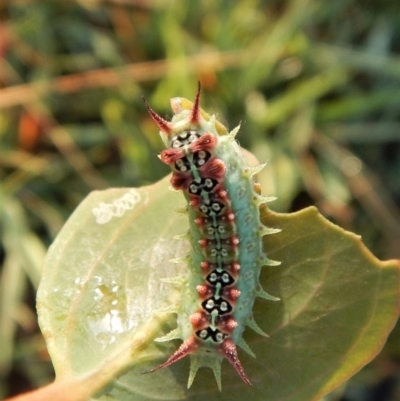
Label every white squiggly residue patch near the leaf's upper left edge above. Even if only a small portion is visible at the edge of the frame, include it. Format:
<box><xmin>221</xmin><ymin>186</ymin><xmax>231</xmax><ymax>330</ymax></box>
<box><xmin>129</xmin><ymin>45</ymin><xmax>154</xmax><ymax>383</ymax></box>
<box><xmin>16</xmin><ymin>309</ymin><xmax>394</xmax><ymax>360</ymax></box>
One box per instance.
<box><xmin>92</xmin><ymin>188</ymin><xmax>142</xmax><ymax>224</ymax></box>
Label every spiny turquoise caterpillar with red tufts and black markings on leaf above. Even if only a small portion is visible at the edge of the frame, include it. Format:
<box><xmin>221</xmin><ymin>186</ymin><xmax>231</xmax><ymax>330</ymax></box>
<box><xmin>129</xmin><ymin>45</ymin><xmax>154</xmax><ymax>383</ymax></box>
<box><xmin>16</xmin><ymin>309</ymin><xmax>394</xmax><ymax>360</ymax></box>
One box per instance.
<box><xmin>144</xmin><ymin>83</ymin><xmax>280</xmax><ymax>390</ymax></box>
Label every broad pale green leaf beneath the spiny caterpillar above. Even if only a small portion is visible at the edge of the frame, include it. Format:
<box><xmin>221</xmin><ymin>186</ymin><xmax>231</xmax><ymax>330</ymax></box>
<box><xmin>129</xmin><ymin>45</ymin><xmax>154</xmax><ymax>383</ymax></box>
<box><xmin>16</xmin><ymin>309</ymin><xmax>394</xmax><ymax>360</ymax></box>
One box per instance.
<box><xmin>37</xmin><ymin>179</ymin><xmax>399</xmax><ymax>401</ymax></box>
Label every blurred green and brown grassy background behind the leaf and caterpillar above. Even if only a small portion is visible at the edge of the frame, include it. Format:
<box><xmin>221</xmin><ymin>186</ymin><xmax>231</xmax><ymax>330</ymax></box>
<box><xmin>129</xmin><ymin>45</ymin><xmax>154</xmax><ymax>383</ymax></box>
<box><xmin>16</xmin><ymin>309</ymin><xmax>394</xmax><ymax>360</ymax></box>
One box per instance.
<box><xmin>0</xmin><ymin>0</ymin><xmax>400</xmax><ymax>401</ymax></box>
